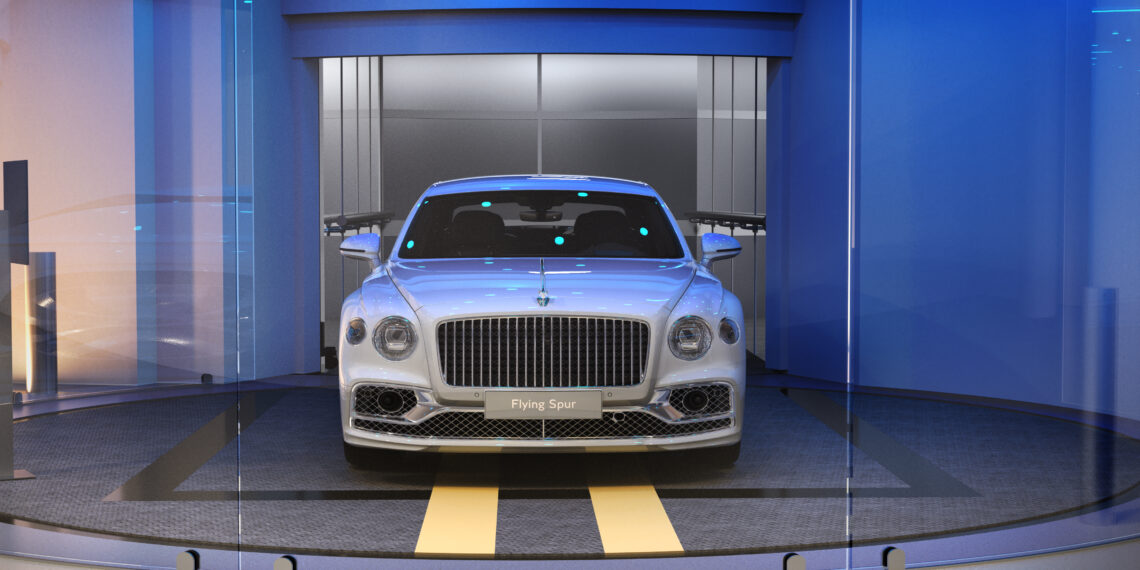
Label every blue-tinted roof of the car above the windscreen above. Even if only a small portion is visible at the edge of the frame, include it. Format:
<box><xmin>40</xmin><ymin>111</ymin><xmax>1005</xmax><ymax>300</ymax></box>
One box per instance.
<box><xmin>424</xmin><ymin>174</ymin><xmax>657</xmax><ymax>196</ymax></box>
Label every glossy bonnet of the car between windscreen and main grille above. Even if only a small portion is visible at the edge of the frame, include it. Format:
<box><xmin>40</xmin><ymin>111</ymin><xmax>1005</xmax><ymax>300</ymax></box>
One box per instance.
<box><xmin>388</xmin><ymin>258</ymin><xmax>697</xmax><ymax>320</ymax></box>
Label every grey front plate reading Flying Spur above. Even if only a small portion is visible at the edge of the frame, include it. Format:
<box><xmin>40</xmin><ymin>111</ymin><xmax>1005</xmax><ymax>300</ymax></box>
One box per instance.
<box><xmin>483</xmin><ymin>390</ymin><xmax>602</xmax><ymax>420</ymax></box>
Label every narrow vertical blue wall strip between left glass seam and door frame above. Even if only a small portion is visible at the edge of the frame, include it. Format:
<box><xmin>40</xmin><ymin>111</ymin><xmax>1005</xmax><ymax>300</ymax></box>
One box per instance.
<box><xmin>247</xmin><ymin>0</ymin><xmax>320</xmax><ymax>377</ymax></box>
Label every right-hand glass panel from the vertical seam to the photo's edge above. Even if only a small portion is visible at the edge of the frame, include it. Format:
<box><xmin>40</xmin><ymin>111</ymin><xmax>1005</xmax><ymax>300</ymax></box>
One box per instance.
<box><xmin>850</xmin><ymin>0</ymin><xmax>1140</xmax><ymax>565</ymax></box>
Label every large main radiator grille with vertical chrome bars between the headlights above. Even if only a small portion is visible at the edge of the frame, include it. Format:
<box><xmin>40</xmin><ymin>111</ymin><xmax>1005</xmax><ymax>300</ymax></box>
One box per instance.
<box><xmin>437</xmin><ymin>316</ymin><xmax>650</xmax><ymax>388</ymax></box>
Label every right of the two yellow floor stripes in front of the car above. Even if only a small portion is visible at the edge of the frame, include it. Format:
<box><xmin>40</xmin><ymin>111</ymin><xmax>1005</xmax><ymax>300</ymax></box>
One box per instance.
<box><xmin>589</xmin><ymin>457</ymin><xmax>684</xmax><ymax>555</ymax></box>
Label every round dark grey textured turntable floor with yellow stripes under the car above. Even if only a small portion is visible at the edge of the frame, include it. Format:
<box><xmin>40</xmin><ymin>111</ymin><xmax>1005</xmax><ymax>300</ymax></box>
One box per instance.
<box><xmin>0</xmin><ymin>376</ymin><xmax>1140</xmax><ymax>557</ymax></box>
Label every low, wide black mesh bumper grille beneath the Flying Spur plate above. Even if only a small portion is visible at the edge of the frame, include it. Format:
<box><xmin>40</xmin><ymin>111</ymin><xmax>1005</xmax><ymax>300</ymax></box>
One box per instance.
<box><xmin>353</xmin><ymin>412</ymin><xmax>732</xmax><ymax>439</ymax></box>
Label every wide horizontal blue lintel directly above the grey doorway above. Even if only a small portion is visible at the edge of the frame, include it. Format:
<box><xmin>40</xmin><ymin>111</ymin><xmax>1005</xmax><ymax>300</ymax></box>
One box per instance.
<box><xmin>288</xmin><ymin>10</ymin><xmax>796</xmax><ymax>57</ymax></box>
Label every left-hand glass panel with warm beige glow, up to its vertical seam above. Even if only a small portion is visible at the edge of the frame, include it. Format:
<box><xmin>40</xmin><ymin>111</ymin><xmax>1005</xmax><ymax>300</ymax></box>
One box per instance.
<box><xmin>0</xmin><ymin>2</ymin><xmax>253</xmax><ymax>568</ymax></box>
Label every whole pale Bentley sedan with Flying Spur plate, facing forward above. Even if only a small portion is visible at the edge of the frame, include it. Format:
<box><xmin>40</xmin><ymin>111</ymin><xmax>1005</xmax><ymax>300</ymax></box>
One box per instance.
<box><xmin>339</xmin><ymin>176</ymin><xmax>746</xmax><ymax>464</ymax></box>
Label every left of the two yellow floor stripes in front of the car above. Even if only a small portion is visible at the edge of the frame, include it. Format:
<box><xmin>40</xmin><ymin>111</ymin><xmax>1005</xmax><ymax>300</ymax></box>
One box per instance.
<box><xmin>416</xmin><ymin>455</ymin><xmax>499</xmax><ymax>557</ymax></box>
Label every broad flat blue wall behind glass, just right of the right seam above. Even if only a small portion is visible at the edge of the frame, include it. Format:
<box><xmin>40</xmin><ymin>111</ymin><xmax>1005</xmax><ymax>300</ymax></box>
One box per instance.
<box><xmin>858</xmin><ymin>0</ymin><xmax>1066</xmax><ymax>401</ymax></box>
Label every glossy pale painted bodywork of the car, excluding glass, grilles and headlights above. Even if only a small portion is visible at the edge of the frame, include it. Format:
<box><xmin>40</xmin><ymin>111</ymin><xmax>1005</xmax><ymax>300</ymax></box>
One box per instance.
<box><xmin>340</xmin><ymin>176</ymin><xmax>747</xmax><ymax>451</ymax></box>
